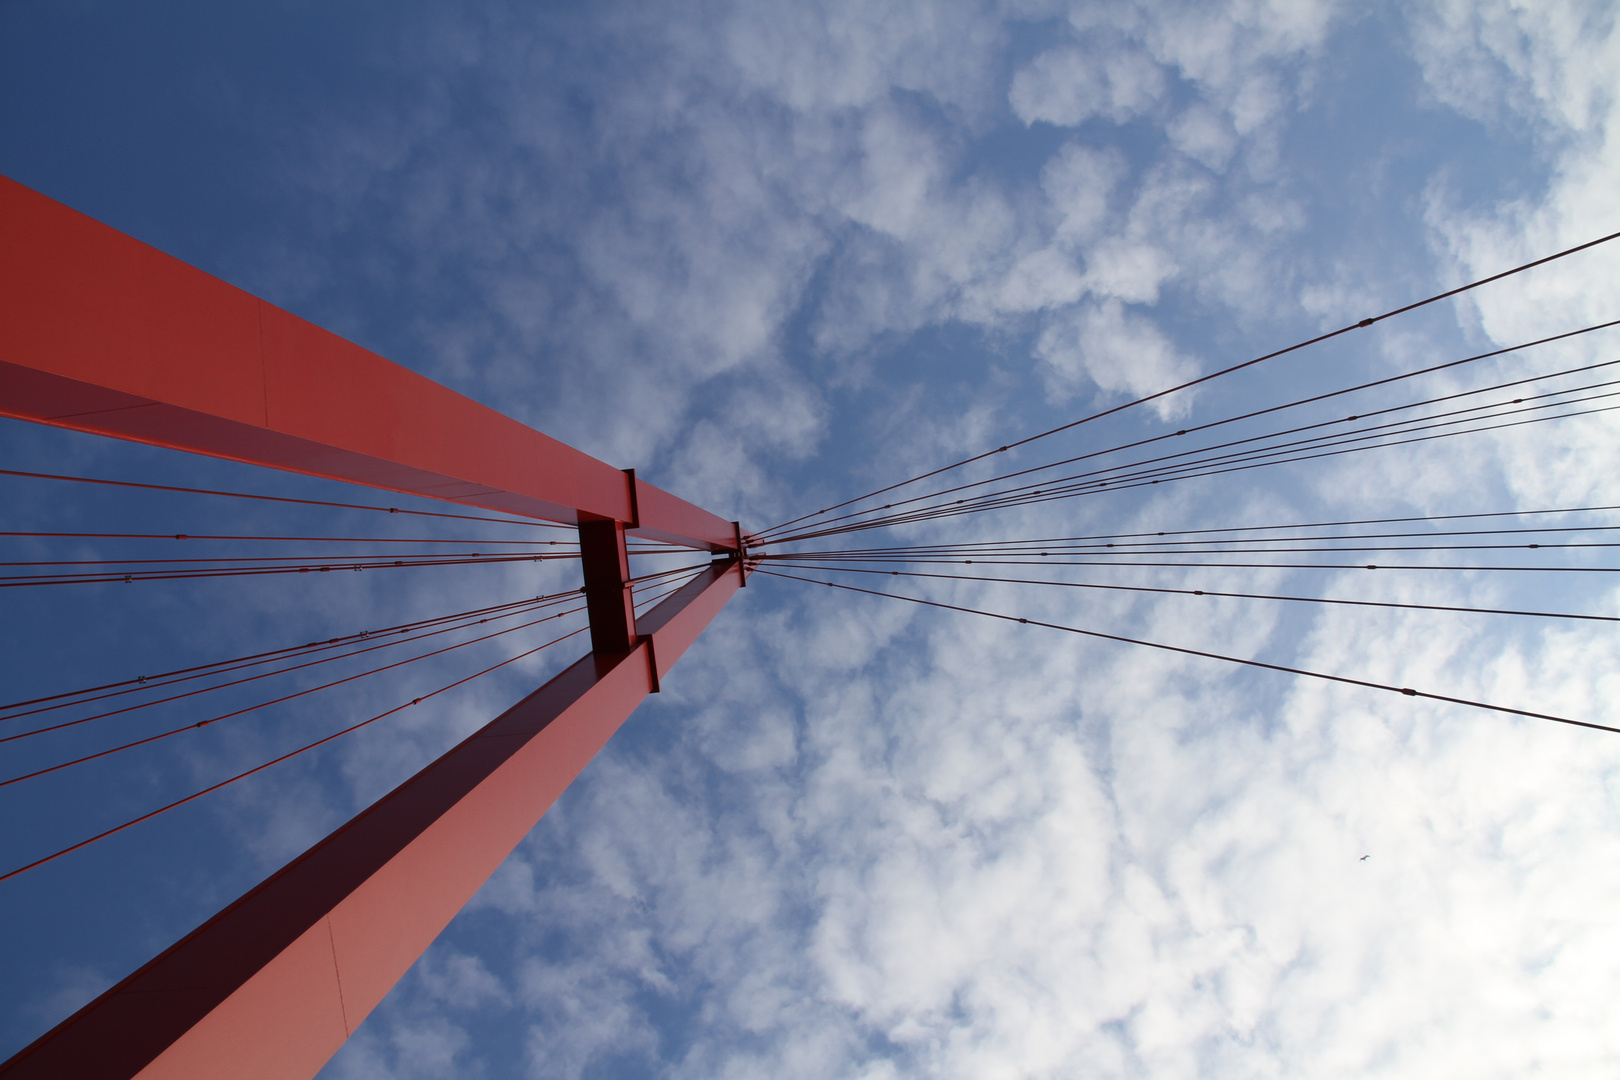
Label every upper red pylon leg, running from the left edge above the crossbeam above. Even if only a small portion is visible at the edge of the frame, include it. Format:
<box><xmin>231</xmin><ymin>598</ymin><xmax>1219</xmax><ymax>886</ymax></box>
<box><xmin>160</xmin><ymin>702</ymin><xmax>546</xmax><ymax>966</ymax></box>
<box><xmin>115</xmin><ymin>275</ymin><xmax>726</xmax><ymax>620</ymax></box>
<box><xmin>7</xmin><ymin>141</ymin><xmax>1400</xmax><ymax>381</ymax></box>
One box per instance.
<box><xmin>0</xmin><ymin>176</ymin><xmax>735</xmax><ymax>552</ymax></box>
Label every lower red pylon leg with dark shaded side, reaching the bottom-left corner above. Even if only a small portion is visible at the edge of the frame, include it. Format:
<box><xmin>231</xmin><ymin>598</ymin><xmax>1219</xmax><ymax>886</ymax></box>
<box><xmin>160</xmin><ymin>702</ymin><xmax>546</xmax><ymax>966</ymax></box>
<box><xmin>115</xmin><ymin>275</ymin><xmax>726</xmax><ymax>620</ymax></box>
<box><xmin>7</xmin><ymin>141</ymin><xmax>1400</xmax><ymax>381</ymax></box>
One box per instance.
<box><xmin>0</xmin><ymin>560</ymin><xmax>742</xmax><ymax>1080</ymax></box>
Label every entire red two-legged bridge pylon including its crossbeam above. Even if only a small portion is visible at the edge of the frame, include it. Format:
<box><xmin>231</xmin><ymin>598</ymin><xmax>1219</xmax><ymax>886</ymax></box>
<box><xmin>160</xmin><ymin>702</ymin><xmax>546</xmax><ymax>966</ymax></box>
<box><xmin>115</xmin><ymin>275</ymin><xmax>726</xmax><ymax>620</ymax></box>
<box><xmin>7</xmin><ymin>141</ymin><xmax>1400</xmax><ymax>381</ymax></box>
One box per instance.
<box><xmin>0</xmin><ymin>178</ymin><xmax>747</xmax><ymax>1080</ymax></box>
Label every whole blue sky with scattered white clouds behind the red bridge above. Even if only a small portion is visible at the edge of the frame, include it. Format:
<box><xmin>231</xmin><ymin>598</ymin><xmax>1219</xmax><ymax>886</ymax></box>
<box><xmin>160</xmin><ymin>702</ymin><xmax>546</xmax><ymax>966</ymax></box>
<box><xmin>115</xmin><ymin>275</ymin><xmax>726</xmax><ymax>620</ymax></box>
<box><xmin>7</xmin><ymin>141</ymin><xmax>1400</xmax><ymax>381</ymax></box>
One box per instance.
<box><xmin>0</xmin><ymin>0</ymin><xmax>1620</xmax><ymax>1080</ymax></box>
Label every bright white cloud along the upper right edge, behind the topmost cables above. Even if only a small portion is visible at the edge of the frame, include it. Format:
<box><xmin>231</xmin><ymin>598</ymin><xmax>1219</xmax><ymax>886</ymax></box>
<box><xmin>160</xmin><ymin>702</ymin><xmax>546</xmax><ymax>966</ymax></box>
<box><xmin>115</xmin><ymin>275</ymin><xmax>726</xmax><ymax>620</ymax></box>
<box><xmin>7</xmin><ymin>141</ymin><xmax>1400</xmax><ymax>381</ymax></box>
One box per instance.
<box><xmin>1414</xmin><ymin>3</ymin><xmax>1620</xmax><ymax>505</ymax></box>
